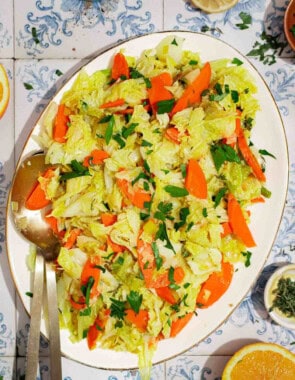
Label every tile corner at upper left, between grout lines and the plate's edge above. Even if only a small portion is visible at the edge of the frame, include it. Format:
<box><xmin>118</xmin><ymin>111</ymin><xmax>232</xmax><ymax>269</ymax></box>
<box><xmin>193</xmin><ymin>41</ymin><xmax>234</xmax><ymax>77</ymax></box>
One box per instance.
<box><xmin>15</xmin><ymin>59</ymin><xmax>85</xmax><ymax>159</ymax></box>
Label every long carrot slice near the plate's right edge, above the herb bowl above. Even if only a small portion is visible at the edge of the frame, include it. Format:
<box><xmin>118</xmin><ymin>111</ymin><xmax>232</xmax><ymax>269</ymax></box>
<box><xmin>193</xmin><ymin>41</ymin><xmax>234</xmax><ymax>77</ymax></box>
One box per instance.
<box><xmin>227</xmin><ymin>194</ymin><xmax>256</xmax><ymax>247</ymax></box>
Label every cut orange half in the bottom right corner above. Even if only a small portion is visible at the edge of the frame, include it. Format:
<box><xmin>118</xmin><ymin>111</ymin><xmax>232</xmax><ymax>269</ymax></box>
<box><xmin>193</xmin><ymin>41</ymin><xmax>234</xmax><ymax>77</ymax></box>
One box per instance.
<box><xmin>222</xmin><ymin>343</ymin><xmax>295</xmax><ymax>380</ymax></box>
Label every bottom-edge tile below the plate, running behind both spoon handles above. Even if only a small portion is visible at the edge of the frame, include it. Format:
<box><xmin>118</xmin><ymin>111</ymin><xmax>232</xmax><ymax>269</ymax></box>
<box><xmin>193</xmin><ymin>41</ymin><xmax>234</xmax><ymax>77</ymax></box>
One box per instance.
<box><xmin>16</xmin><ymin>357</ymin><xmax>165</xmax><ymax>380</ymax></box>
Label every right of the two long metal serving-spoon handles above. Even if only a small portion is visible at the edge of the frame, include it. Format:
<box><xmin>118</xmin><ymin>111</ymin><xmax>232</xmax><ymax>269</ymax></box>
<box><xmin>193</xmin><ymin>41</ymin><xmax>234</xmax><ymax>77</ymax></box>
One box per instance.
<box><xmin>45</xmin><ymin>262</ymin><xmax>62</xmax><ymax>380</ymax></box>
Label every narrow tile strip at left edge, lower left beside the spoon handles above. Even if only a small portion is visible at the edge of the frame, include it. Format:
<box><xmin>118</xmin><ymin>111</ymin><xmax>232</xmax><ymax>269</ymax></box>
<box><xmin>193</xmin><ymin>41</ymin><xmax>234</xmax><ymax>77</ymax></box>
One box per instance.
<box><xmin>0</xmin><ymin>208</ymin><xmax>16</xmax><ymax>358</ymax></box>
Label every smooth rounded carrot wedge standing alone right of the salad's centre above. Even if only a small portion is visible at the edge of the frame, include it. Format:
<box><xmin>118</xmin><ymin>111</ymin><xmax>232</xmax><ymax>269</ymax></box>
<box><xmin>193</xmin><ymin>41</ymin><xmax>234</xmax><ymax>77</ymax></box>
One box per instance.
<box><xmin>184</xmin><ymin>159</ymin><xmax>207</xmax><ymax>199</ymax></box>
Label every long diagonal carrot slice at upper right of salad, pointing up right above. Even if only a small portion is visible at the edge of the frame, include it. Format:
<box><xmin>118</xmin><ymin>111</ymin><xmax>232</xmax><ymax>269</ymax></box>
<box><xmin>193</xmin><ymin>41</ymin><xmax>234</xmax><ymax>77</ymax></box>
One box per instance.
<box><xmin>171</xmin><ymin>62</ymin><xmax>211</xmax><ymax>115</ymax></box>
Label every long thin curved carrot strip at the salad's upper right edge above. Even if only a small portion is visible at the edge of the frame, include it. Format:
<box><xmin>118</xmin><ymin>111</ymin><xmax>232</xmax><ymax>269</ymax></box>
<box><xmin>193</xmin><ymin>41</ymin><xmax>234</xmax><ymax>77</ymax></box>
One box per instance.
<box><xmin>236</xmin><ymin>111</ymin><xmax>266</xmax><ymax>182</ymax></box>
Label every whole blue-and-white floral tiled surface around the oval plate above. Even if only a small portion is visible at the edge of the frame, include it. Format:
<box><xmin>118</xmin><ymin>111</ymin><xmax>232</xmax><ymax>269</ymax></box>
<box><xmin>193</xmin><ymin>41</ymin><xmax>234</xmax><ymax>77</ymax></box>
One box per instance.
<box><xmin>0</xmin><ymin>0</ymin><xmax>295</xmax><ymax>380</ymax></box>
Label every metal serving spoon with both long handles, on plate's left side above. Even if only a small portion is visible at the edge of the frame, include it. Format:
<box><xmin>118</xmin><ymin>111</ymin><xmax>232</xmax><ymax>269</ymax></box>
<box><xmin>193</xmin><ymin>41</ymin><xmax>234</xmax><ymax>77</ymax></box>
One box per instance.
<box><xmin>10</xmin><ymin>154</ymin><xmax>62</xmax><ymax>380</ymax></box>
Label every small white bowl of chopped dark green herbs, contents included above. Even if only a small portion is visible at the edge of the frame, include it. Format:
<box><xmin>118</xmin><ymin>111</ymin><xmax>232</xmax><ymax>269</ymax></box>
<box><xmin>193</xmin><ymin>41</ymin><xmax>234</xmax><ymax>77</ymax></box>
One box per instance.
<box><xmin>264</xmin><ymin>264</ymin><xmax>295</xmax><ymax>329</ymax></box>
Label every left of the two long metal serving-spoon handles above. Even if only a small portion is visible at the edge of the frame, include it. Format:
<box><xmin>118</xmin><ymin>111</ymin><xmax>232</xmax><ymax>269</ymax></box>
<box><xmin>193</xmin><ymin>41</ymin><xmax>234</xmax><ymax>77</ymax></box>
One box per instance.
<box><xmin>26</xmin><ymin>253</ymin><xmax>44</xmax><ymax>380</ymax></box>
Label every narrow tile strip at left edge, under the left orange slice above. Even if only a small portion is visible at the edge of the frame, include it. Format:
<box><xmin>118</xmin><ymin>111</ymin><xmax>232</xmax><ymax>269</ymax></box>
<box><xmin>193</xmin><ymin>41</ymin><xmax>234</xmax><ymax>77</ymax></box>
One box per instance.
<box><xmin>0</xmin><ymin>59</ymin><xmax>14</xmax><ymax>207</ymax></box>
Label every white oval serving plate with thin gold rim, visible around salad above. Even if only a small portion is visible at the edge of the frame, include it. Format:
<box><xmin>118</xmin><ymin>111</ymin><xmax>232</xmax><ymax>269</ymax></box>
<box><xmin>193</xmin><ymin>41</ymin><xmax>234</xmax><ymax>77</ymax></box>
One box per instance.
<box><xmin>6</xmin><ymin>31</ymin><xmax>288</xmax><ymax>369</ymax></box>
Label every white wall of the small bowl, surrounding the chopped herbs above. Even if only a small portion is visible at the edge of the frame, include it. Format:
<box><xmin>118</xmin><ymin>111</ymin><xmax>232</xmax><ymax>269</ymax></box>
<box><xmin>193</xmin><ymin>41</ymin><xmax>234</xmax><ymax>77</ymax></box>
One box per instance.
<box><xmin>264</xmin><ymin>264</ymin><xmax>295</xmax><ymax>330</ymax></box>
